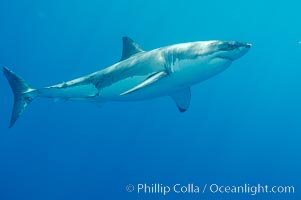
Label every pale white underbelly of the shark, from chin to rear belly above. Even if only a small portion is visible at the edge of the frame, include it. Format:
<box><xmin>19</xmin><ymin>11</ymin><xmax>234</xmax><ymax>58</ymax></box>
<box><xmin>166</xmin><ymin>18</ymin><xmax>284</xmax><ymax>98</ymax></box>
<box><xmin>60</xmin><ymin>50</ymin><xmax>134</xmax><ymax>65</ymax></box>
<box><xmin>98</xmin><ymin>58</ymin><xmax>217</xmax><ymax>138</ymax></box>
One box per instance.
<box><xmin>99</xmin><ymin>59</ymin><xmax>230</xmax><ymax>101</ymax></box>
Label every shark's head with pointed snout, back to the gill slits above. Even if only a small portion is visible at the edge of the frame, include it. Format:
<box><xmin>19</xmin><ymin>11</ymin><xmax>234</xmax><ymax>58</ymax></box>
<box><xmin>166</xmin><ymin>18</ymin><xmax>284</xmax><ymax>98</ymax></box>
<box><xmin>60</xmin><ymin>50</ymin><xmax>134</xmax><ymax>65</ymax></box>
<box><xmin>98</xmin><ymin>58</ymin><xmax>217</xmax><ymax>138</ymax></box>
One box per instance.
<box><xmin>165</xmin><ymin>41</ymin><xmax>251</xmax><ymax>83</ymax></box>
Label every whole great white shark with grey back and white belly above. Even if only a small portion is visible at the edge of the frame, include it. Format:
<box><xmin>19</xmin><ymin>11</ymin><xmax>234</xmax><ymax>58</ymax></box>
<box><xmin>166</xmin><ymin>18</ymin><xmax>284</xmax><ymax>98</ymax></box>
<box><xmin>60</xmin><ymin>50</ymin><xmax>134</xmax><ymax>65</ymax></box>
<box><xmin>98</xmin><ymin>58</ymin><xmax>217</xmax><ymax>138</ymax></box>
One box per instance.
<box><xmin>3</xmin><ymin>37</ymin><xmax>251</xmax><ymax>127</ymax></box>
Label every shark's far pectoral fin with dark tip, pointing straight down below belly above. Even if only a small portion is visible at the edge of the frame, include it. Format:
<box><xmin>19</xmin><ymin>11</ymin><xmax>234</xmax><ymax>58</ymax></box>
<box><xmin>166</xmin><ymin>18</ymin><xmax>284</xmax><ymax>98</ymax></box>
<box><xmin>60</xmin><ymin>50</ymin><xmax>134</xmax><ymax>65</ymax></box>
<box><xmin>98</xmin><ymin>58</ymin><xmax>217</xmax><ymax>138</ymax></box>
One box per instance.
<box><xmin>170</xmin><ymin>87</ymin><xmax>191</xmax><ymax>112</ymax></box>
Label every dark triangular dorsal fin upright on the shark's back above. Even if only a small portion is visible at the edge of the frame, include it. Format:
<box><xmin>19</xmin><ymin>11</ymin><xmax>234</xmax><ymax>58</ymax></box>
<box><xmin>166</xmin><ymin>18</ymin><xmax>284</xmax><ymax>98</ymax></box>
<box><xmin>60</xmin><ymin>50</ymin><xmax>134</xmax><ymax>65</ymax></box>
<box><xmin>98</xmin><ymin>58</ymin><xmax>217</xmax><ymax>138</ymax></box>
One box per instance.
<box><xmin>120</xmin><ymin>37</ymin><xmax>143</xmax><ymax>61</ymax></box>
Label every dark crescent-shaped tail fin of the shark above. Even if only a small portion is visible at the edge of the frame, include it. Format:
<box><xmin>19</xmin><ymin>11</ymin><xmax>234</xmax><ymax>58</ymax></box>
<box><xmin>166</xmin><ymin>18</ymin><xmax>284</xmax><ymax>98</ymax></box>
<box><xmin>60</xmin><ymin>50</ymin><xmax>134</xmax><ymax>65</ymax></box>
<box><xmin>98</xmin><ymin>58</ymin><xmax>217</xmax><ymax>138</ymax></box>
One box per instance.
<box><xmin>3</xmin><ymin>67</ymin><xmax>37</xmax><ymax>128</ymax></box>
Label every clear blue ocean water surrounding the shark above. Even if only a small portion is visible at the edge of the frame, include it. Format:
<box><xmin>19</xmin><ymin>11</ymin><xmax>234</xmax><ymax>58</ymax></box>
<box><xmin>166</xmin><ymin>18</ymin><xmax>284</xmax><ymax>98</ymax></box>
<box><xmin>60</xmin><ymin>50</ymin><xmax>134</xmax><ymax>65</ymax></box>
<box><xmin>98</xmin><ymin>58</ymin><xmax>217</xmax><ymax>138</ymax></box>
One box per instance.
<box><xmin>0</xmin><ymin>0</ymin><xmax>301</xmax><ymax>200</ymax></box>
